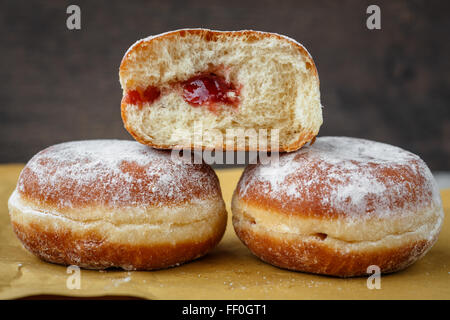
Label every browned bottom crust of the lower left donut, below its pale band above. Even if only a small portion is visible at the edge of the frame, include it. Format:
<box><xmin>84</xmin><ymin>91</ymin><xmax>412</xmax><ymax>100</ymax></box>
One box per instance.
<box><xmin>12</xmin><ymin>222</ymin><xmax>225</xmax><ymax>270</ymax></box>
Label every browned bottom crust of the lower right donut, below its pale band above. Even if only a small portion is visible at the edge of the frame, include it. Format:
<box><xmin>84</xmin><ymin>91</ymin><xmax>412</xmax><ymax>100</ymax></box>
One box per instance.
<box><xmin>232</xmin><ymin>196</ymin><xmax>438</xmax><ymax>277</ymax></box>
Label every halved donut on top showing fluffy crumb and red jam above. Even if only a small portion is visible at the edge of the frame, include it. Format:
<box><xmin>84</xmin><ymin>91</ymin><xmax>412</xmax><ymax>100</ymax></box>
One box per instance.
<box><xmin>119</xmin><ymin>29</ymin><xmax>322</xmax><ymax>151</ymax></box>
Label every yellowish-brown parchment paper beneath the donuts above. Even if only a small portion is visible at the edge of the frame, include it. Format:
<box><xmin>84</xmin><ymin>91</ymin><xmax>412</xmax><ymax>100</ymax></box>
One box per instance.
<box><xmin>0</xmin><ymin>164</ymin><xmax>450</xmax><ymax>299</ymax></box>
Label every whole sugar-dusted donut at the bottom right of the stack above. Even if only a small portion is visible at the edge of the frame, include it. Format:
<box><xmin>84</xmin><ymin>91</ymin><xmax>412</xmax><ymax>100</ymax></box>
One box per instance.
<box><xmin>232</xmin><ymin>137</ymin><xmax>443</xmax><ymax>277</ymax></box>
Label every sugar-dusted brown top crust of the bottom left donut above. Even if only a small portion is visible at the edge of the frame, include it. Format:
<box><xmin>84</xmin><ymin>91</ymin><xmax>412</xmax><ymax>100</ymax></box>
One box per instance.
<box><xmin>17</xmin><ymin>140</ymin><xmax>220</xmax><ymax>209</ymax></box>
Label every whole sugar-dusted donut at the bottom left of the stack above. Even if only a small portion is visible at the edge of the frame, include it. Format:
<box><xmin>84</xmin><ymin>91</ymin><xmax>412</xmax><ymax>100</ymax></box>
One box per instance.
<box><xmin>9</xmin><ymin>140</ymin><xmax>227</xmax><ymax>270</ymax></box>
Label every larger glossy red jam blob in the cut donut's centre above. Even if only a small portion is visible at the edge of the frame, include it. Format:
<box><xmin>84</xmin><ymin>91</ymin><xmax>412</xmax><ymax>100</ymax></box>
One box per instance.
<box><xmin>182</xmin><ymin>73</ymin><xmax>239</xmax><ymax>108</ymax></box>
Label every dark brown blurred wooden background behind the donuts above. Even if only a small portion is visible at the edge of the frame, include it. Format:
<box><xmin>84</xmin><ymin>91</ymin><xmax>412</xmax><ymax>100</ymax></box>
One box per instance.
<box><xmin>0</xmin><ymin>0</ymin><xmax>450</xmax><ymax>170</ymax></box>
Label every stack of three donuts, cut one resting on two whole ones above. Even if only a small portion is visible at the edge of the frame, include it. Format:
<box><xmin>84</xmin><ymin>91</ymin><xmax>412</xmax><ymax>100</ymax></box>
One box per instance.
<box><xmin>9</xmin><ymin>29</ymin><xmax>443</xmax><ymax>277</ymax></box>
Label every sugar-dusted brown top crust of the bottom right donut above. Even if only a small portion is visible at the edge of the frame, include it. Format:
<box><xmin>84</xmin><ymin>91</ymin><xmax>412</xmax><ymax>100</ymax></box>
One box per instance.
<box><xmin>237</xmin><ymin>137</ymin><xmax>441</xmax><ymax>217</ymax></box>
